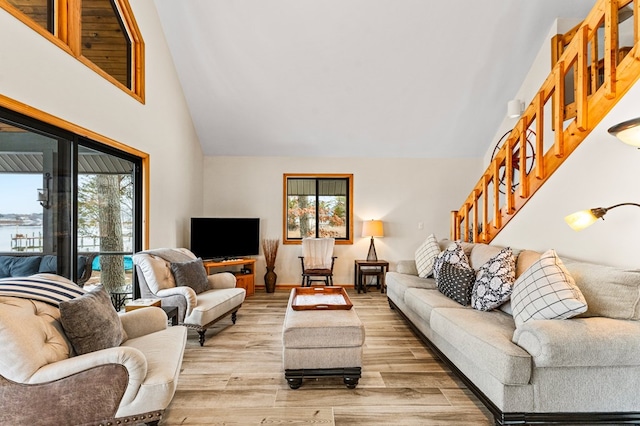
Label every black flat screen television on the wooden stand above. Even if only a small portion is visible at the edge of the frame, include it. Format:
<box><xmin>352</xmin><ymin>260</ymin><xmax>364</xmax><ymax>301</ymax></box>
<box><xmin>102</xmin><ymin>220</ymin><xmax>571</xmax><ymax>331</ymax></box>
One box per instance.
<box><xmin>191</xmin><ymin>217</ymin><xmax>260</xmax><ymax>260</ymax></box>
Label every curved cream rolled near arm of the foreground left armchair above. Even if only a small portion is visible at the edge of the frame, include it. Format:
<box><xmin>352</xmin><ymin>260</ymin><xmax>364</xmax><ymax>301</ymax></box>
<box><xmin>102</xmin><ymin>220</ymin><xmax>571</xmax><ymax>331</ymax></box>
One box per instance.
<box><xmin>28</xmin><ymin>346</ymin><xmax>147</xmax><ymax>405</ymax></box>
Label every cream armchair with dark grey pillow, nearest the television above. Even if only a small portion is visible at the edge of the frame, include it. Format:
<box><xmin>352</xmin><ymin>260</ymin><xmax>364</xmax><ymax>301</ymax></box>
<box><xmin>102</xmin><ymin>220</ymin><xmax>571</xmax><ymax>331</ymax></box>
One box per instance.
<box><xmin>133</xmin><ymin>248</ymin><xmax>246</xmax><ymax>346</ymax></box>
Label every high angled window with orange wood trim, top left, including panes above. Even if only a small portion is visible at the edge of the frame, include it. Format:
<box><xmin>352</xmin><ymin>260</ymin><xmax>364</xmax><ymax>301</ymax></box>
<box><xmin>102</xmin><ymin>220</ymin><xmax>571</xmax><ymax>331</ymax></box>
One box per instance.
<box><xmin>0</xmin><ymin>0</ymin><xmax>144</xmax><ymax>102</ymax></box>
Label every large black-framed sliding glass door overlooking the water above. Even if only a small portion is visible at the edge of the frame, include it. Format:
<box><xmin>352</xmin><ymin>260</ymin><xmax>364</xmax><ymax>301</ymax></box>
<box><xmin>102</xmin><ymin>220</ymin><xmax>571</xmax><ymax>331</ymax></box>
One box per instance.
<box><xmin>0</xmin><ymin>108</ymin><xmax>143</xmax><ymax>307</ymax></box>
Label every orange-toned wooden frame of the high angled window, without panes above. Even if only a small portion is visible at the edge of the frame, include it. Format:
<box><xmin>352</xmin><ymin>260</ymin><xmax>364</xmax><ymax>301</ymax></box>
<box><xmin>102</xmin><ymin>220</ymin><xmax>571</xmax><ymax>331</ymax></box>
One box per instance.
<box><xmin>0</xmin><ymin>0</ymin><xmax>145</xmax><ymax>104</ymax></box>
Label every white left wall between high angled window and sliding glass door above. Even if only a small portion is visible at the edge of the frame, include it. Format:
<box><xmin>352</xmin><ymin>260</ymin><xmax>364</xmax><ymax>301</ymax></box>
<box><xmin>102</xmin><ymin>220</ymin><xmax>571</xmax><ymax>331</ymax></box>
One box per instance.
<box><xmin>0</xmin><ymin>0</ymin><xmax>203</xmax><ymax>247</ymax></box>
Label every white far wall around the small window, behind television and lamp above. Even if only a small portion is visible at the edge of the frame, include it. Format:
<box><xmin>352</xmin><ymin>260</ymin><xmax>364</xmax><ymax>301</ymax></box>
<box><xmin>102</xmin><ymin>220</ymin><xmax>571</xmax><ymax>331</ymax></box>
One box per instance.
<box><xmin>203</xmin><ymin>157</ymin><xmax>481</xmax><ymax>285</ymax></box>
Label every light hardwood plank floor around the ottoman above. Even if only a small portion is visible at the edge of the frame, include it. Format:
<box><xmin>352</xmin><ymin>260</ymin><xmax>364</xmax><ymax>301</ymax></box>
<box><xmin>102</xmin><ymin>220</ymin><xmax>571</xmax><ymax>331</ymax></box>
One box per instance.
<box><xmin>160</xmin><ymin>288</ymin><xmax>493</xmax><ymax>425</ymax></box>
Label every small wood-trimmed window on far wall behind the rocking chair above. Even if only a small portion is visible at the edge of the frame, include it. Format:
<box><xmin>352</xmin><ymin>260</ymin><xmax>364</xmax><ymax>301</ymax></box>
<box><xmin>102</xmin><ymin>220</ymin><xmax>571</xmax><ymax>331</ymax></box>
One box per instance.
<box><xmin>283</xmin><ymin>174</ymin><xmax>353</xmax><ymax>244</ymax></box>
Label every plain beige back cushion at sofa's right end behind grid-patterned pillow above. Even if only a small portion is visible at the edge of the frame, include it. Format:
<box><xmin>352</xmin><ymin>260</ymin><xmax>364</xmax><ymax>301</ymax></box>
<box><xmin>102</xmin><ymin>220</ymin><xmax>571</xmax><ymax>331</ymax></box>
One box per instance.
<box><xmin>563</xmin><ymin>259</ymin><xmax>640</xmax><ymax>320</ymax></box>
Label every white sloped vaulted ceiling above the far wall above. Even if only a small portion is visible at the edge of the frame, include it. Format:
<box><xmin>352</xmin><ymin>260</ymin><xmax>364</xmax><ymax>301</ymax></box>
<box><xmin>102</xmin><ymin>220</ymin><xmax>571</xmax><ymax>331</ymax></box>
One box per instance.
<box><xmin>154</xmin><ymin>0</ymin><xmax>594</xmax><ymax>158</ymax></box>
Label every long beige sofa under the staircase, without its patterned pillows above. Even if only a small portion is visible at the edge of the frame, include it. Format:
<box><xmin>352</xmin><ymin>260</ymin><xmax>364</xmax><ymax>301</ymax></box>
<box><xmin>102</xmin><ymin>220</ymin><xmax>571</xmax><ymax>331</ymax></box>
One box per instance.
<box><xmin>386</xmin><ymin>241</ymin><xmax>640</xmax><ymax>424</ymax></box>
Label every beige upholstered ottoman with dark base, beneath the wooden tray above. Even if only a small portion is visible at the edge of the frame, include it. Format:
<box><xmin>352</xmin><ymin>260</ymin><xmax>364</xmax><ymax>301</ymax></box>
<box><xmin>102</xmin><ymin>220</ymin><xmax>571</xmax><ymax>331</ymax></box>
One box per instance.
<box><xmin>282</xmin><ymin>289</ymin><xmax>364</xmax><ymax>389</ymax></box>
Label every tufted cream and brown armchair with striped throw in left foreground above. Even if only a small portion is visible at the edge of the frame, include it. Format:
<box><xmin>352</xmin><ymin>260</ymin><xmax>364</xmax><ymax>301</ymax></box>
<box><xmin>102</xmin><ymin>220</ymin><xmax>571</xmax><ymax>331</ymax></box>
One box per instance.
<box><xmin>0</xmin><ymin>274</ymin><xmax>187</xmax><ymax>425</ymax></box>
